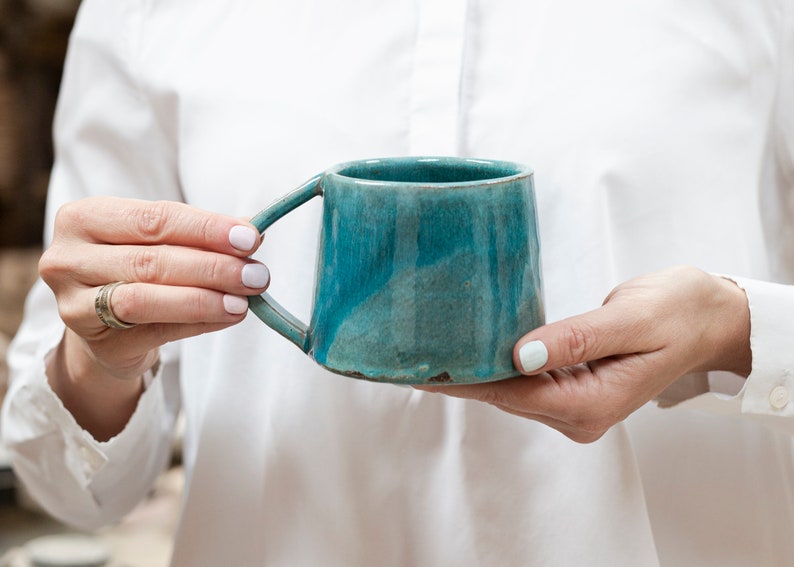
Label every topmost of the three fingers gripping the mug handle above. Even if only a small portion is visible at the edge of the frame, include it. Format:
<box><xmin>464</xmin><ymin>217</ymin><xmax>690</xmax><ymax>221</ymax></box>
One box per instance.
<box><xmin>55</xmin><ymin>197</ymin><xmax>261</xmax><ymax>256</ymax></box>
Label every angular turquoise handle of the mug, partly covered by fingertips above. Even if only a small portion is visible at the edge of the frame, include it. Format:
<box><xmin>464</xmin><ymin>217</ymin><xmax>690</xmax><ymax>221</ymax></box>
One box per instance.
<box><xmin>248</xmin><ymin>175</ymin><xmax>323</xmax><ymax>353</ymax></box>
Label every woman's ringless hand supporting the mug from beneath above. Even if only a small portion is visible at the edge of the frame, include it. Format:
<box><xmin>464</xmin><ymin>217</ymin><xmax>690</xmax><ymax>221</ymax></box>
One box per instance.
<box><xmin>420</xmin><ymin>267</ymin><xmax>751</xmax><ymax>443</ymax></box>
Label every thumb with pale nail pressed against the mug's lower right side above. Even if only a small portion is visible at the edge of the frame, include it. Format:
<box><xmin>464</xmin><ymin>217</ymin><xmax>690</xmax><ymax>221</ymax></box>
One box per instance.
<box><xmin>513</xmin><ymin>303</ymin><xmax>647</xmax><ymax>374</ymax></box>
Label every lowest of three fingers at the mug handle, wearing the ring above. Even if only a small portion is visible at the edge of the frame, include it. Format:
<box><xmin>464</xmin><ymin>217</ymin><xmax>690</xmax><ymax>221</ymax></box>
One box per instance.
<box><xmin>59</xmin><ymin>283</ymin><xmax>248</xmax><ymax>336</ymax></box>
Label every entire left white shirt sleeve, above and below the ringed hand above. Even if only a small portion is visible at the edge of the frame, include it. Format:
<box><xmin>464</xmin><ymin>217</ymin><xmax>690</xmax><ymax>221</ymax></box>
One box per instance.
<box><xmin>0</xmin><ymin>0</ymin><xmax>181</xmax><ymax>529</ymax></box>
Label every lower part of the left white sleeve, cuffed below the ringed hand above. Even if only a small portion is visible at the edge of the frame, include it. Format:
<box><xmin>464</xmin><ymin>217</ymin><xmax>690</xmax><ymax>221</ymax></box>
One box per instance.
<box><xmin>0</xmin><ymin>281</ymin><xmax>179</xmax><ymax>529</ymax></box>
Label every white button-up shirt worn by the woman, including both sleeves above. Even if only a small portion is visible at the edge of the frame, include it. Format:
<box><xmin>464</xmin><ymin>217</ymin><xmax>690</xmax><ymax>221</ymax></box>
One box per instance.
<box><xmin>2</xmin><ymin>0</ymin><xmax>794</xmax><ymax>567</ymax></box>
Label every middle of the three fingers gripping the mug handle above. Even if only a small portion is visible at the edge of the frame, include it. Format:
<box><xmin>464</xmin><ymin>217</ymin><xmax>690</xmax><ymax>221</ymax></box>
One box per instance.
<box><xmin>49</xmin><ymin>244</ymin><xmax>270</xmax><ymax>295</ymax></box>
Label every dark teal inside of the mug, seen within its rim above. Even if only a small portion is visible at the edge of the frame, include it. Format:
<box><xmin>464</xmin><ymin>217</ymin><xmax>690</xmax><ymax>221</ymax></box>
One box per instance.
<box><xmin>334</xmin><ymin>157</ymin><xmax>528</xmax><ymax>185</ymax></box>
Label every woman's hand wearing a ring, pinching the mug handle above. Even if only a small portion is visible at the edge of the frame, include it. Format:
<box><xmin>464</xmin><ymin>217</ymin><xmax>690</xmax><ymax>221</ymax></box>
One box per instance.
<box><xmin>39</xmin><ymin>197</ymin><xmax>269</xmax><ymax>438</ymax></box>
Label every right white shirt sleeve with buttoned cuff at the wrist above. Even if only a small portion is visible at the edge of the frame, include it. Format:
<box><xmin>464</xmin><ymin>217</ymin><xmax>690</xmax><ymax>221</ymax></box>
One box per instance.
<box><xmin>657</xmin><ymin>4</ymin><xmax>794</xmax><ymax>435</ymax></box>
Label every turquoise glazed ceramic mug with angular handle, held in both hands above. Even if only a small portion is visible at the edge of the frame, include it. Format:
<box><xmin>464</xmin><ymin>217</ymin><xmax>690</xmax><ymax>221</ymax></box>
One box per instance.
<box><xmin>249</xmin><ymin>157</ymin><xmax>544</xmax><ymax>384</ymax></box>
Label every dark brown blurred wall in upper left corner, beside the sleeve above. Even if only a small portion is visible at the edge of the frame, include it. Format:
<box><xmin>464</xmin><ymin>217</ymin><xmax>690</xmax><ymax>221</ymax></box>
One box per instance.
<box><xmin>0</xmin><ymin>0</ymin><xmax>79</xmax><ymax>248</ymax></box>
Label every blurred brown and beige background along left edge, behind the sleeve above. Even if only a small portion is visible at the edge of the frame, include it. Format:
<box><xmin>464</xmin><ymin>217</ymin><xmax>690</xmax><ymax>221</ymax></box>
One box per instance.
<box><xmin>0</xmin><ymin>0</ymin><xmax>182</xmax><ymax>567</ymax></box>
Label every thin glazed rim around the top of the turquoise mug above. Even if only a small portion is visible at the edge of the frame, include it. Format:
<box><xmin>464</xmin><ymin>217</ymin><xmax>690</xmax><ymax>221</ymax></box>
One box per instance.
<box><xmin>325</xmin><ymin>156</ymin><xmax>534</xmax><ymax>187</ymax></box>
